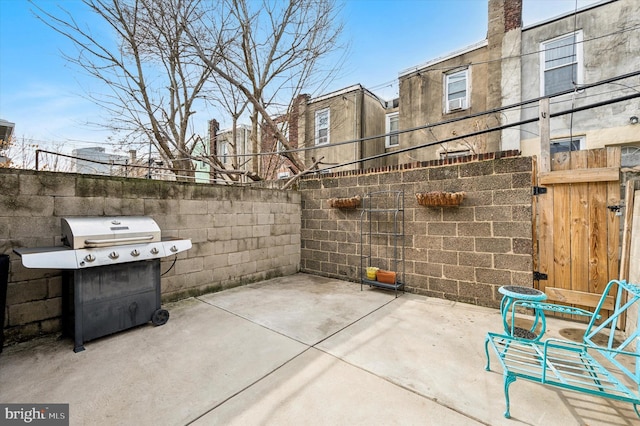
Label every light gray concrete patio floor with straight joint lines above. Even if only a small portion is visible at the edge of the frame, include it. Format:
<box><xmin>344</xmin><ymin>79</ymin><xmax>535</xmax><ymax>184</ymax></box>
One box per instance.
<box><xmin>0</xmin><ymin>274</ymin><xmax>638</xmax><ymax>426</ymax></box>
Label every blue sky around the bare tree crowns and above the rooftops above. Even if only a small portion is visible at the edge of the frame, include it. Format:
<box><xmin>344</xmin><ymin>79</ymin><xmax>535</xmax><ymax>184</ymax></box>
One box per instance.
<box><xmin>0</xmin><ymin>0</ymin><xmax>597</xmax><ymax>154</ymax></box>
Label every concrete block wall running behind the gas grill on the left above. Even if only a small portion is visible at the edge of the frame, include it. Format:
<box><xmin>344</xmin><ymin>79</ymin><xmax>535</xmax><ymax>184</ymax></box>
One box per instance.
<box><xmin>0</xmin><ymin>169</ymin><xmax>301</xmax><ymax>343</ymax></box>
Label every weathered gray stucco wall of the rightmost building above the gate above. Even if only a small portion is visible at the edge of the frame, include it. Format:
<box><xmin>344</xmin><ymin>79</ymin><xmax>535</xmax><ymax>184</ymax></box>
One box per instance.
<box><xmin>520</xmin><ymin>0</ymin><xmax>640</xmax><ymax>155</ymax></box>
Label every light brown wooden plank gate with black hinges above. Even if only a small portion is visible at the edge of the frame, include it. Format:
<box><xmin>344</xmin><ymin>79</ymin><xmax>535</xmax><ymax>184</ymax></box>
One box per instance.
<box><xmin>534</xmin><ymin>148</ymin><xmax>621</xmax><ymax>310</ymax></box>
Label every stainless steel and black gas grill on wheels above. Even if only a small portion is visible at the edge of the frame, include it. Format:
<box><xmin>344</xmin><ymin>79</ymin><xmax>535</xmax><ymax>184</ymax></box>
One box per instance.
<box><xmin>14</xmin><ymin>216</ymin><xmax>191</xmax><ymax>352</ymax></box>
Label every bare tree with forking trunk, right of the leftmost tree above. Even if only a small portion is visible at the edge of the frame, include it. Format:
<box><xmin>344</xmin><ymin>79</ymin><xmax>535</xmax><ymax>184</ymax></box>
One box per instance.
<box><xmin>184</xmin><ymin>0</ymin><xmax>343</xmax><ymax>178</ymax></box>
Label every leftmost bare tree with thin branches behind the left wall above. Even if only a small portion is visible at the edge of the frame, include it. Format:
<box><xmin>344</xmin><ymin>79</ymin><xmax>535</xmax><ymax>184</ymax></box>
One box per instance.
<box><xmin>35</xmin><ymin>0</ymin><xmax>234</xmax><ymax>178</ymax></box>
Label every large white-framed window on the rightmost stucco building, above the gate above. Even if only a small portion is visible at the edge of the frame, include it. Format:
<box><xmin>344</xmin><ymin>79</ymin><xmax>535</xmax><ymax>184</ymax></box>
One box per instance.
<box><xmin>540</xmin><ymin>31</ymin><xmax>582</xmax><ymax>96</ymax></box>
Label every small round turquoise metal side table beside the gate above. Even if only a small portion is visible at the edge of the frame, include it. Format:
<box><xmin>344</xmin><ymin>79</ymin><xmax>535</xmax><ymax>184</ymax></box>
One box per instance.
<box><xmin>498</xmin><ymin>285</ymin><xmax>547</xmax><ymax>340</ymax></box>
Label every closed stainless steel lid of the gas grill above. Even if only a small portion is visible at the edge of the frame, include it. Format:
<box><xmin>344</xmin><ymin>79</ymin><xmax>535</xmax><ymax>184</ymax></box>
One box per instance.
<box><xmin>62</xmin><ymin>216</ymin><xmax>161</xmax><ymax>249</ymax></box>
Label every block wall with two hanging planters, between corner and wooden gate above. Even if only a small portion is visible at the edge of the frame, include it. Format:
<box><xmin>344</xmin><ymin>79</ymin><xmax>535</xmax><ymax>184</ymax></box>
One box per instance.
<box><xmin>300</xmin><ymin>152</ymin><xmax>533</xmax><ymax>307</ymax></box>
